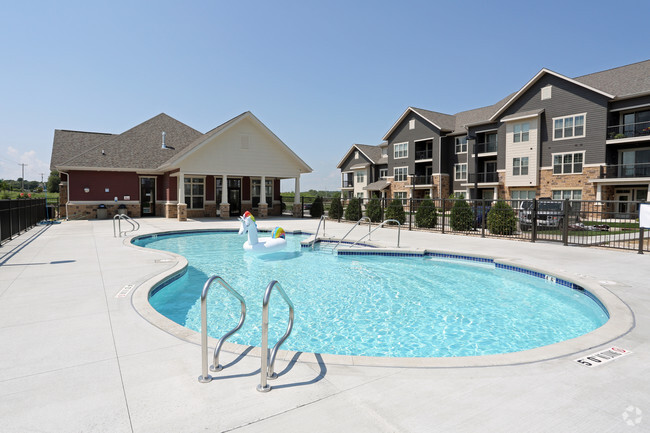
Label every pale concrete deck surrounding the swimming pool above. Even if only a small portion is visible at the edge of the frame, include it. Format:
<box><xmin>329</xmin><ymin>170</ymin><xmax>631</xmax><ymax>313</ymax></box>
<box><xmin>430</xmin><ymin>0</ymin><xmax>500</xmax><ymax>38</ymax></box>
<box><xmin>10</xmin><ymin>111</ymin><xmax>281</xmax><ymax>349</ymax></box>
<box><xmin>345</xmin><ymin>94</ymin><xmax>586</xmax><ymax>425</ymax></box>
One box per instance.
<box><xmin>0</xmin><ymin>218</ymin><xmax>650</xmax><ymax>432</ymax></box>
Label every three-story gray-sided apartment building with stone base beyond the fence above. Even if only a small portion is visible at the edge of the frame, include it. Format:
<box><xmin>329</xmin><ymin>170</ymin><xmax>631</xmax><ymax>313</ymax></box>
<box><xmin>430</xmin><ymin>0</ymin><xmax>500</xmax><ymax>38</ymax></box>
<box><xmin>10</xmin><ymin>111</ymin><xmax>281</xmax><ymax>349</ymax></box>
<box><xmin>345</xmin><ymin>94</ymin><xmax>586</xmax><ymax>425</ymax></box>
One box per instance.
<box><xmin>339</xmin><ymin>60</ymin><xmax>650</xmax><ymax>215</ymax></box>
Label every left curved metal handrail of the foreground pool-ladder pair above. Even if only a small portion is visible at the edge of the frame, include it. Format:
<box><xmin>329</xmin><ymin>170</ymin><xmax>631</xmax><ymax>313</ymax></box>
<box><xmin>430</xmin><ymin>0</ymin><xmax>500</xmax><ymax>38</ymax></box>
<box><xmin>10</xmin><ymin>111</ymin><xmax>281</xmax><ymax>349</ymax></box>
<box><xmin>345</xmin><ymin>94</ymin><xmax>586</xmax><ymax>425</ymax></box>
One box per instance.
<box><xmin>199</xmin><ymin>275</ymin><xmax>246</xmax><ymax>383</ymax></box>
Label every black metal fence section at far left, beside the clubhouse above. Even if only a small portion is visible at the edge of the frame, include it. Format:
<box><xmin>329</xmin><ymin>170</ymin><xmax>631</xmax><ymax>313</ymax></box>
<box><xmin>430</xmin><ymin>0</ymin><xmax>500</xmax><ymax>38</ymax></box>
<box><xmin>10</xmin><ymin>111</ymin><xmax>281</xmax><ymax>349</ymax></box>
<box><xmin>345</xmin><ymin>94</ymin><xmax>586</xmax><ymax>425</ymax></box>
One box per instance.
<box><xmin>0</xmin><ymin>198</ymin><xmax>47</xmax><ymax>243</ymax></box>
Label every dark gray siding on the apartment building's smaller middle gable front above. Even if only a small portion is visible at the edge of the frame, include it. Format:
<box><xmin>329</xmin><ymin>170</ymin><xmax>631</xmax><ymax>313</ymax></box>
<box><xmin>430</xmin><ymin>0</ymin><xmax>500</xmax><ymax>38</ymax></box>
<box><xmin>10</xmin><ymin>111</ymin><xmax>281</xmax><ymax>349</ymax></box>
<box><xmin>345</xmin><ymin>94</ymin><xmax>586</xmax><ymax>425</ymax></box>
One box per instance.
<box><xmin>388</xmin><ymin>112</ymin><xmax>440</xmax><ymax>176</ymax></box>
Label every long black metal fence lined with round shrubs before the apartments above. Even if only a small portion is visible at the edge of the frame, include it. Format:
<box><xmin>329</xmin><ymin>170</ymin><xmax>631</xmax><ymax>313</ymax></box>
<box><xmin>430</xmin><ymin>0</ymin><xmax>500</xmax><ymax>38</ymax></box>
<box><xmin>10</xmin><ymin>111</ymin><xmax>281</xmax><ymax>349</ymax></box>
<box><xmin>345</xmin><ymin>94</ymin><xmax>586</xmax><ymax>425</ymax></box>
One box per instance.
<box><xmin>301</xmin><ymin>197</ymin><xmax>650</xmax><ymax>254</ymax></box>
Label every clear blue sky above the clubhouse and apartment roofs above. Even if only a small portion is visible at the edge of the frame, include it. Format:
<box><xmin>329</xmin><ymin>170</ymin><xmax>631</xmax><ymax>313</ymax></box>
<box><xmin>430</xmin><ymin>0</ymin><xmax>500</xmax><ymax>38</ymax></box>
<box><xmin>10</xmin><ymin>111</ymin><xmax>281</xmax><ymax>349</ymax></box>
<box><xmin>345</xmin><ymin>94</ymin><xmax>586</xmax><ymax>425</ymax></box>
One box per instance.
<box><xmin>0</xmin><ymin>0</ymin><xmax>650</xmax><ymax>191</ymax></box>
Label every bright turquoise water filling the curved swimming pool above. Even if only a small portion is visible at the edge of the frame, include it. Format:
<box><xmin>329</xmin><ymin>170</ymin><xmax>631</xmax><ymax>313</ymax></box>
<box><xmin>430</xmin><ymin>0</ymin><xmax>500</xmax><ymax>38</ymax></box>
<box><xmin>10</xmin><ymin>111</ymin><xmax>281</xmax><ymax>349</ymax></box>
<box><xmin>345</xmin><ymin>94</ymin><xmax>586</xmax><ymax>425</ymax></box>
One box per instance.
<box><xmin>134</xmin><ymin>232</ymin><xmax>608</xmax><ymax>357</ymax></box>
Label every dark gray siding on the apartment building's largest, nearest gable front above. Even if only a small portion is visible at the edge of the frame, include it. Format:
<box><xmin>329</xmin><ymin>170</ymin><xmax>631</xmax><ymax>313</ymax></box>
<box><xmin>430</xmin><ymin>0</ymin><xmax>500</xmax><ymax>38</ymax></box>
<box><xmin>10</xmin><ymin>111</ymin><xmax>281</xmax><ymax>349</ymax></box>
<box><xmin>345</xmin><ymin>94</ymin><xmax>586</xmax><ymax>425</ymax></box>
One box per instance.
<box><xmin>498</xmin><ymin>74</ymin><xmax>608</xmax><ymax>168</ymax></box>
